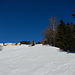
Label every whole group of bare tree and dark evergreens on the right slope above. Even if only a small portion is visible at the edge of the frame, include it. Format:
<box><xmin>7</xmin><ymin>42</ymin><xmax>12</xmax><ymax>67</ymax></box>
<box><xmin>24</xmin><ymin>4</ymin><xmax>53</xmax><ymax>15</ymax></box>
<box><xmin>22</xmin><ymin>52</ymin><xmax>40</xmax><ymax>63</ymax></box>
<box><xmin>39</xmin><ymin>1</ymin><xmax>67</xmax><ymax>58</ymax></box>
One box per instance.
<box><xmin>42</xmin><ymin>17</ymin><xmax>75</xmax><ymax>52</ymax></box>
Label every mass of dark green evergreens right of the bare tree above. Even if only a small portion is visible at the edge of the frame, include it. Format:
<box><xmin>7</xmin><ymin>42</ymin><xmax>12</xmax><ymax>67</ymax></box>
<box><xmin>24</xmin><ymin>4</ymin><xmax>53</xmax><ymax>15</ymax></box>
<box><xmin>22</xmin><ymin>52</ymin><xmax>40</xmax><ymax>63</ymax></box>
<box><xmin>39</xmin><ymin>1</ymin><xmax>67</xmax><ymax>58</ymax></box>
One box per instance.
<box><xmin>56</xmin><ymin>20</ymin><xmax>75</xmax><ymax>52</ymax></box>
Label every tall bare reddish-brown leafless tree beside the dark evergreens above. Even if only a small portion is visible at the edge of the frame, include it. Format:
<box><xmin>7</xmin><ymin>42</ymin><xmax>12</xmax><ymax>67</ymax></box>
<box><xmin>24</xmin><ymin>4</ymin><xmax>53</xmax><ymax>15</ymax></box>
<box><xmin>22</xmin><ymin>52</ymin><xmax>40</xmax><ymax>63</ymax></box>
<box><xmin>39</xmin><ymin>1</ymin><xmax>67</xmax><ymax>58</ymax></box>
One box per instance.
<box><xmin>42</xmin><ymin>17</ymin><xmax>58</xmax><ymax>46</ymax></box>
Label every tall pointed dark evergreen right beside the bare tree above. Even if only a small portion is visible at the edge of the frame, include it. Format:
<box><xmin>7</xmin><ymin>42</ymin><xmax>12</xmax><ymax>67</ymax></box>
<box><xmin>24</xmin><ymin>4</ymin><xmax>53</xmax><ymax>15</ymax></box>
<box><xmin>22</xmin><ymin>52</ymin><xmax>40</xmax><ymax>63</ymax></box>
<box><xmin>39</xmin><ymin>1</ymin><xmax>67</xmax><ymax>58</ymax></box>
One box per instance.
<box><xmin>56</xmin><ymin>19</ymin><xmax>66</xmax><ymax>49</ymax></box>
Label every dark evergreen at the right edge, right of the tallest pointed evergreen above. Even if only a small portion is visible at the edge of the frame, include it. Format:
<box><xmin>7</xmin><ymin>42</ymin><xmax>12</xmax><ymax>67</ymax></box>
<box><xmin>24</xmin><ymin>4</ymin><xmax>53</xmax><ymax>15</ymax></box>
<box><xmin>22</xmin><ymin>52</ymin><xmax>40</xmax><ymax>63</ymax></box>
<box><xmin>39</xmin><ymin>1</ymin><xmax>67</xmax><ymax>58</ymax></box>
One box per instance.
<box><xmin>66</xmin><ymin>23</ymin><xmax>75</xmax><ymax>52</ymax></box>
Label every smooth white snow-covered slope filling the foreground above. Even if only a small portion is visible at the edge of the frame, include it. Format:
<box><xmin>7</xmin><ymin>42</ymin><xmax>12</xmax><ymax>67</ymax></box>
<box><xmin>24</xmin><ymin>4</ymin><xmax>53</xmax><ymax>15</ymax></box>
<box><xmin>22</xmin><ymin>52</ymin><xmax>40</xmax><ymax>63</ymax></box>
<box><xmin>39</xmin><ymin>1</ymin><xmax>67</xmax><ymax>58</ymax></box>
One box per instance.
<box><xmin>0</xmin><ymin>45</ymin><xmax>75</xmax><ymax>75</ymax></box>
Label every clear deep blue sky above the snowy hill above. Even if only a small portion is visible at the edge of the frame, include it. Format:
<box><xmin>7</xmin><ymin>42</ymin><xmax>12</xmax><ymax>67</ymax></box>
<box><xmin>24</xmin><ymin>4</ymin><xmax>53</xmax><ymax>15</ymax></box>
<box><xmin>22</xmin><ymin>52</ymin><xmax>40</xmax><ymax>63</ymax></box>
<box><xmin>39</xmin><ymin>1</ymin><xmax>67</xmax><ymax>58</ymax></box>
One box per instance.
<box><xmin>0</xmin><ymin>0</ymin><xmax>75</xmax><ymax>42</ymax></box>
